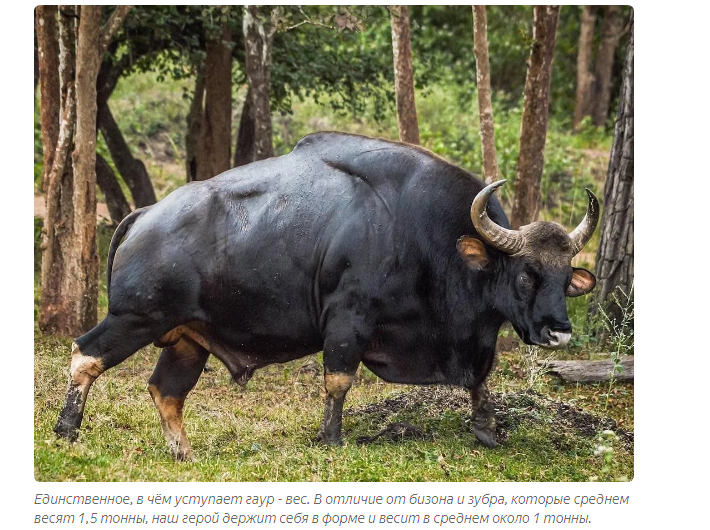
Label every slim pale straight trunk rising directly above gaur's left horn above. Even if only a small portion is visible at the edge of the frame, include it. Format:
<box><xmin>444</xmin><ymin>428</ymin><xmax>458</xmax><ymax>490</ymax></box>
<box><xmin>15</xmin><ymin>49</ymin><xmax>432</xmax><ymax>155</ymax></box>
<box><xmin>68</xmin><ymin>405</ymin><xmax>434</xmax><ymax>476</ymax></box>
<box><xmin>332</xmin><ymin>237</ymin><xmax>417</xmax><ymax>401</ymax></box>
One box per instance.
<box><xmin>473</xmin><ymin>6</ymin><xmax>499</xmax><ymax>184</ymax></box>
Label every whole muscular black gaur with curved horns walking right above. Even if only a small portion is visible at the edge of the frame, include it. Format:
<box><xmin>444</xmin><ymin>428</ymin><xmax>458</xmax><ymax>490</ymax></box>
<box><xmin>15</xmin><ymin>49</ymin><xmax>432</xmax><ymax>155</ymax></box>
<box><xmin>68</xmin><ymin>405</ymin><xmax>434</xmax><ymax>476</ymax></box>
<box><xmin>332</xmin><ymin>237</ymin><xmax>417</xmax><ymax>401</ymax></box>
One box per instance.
<box><xmin>55</xmin><ymin>133</ymin><xmax>598</xmax><ymax>459</ymax></box>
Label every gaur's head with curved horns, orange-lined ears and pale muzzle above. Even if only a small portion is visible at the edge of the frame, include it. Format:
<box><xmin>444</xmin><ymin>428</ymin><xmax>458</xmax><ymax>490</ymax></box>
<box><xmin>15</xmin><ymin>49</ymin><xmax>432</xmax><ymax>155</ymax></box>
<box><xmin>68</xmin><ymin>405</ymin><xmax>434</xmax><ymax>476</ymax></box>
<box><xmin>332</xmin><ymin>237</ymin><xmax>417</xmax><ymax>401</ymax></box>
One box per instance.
<box><xmin>457</xmin><ymin>180</ymin><xmax>599</xmax><ymax>348</ymax></box>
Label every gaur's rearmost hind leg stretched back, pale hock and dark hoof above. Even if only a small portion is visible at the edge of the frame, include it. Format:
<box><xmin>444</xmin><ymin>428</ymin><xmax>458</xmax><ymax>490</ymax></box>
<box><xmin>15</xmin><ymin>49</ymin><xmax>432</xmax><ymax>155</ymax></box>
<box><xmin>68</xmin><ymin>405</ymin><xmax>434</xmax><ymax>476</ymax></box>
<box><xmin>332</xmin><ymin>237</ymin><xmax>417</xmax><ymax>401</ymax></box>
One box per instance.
<box><xmin>54</xmin><ymin>314</ymin><xmax>165</xmax><ymax>441</ymax></box>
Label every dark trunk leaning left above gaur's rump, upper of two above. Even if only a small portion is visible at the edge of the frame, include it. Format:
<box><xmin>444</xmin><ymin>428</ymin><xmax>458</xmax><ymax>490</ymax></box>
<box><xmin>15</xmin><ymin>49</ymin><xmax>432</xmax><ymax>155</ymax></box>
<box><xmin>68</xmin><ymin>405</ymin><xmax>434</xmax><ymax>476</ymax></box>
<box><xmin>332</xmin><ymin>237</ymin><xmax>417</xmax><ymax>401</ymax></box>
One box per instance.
<box><xmin>98</xmin><ymin>99</ymin><xmax>156</xmax><ymax>208</ymax></box>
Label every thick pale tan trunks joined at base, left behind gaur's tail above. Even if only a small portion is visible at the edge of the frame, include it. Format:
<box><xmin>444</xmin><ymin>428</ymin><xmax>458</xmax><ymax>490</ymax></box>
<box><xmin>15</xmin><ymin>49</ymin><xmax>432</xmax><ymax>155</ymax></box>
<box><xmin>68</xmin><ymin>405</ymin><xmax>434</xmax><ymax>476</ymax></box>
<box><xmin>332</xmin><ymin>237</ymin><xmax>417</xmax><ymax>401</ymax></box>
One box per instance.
<box><xmin>39</xmin><ymin>6</ymin><xmax>130</xmax><ymax>336</ymax></box>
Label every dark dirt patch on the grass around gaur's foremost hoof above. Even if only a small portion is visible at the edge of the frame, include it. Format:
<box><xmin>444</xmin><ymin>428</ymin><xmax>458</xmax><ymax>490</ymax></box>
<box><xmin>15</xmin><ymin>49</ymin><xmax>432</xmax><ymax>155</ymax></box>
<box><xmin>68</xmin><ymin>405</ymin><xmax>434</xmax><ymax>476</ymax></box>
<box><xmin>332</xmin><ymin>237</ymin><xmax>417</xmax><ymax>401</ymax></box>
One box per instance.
<box><xmin>343</xmin><ymin>387</ymin><xmax>634</xmax><ymax>451</ymax></box>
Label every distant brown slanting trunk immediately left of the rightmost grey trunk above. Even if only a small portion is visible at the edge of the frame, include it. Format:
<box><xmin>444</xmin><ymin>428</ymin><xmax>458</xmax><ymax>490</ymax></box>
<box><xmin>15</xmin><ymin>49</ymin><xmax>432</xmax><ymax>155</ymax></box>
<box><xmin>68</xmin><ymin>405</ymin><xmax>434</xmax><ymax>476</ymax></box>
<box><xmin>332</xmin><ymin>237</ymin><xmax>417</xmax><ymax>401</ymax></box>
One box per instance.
<box><xmin>592</xmin><ymin>6</ymin><xmax>624</xmax><ymax>127</ymax></box>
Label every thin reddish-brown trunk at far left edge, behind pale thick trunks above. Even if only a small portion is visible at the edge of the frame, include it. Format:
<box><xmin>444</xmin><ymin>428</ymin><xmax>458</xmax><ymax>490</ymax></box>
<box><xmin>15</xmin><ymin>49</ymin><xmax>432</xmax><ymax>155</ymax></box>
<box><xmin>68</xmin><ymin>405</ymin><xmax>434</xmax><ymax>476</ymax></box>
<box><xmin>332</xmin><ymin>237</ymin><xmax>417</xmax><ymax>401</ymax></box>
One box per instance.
<box><xmin>35</xmin><ymin>6</ymin><xmax>60</xmax><ymax>192</ymax></box>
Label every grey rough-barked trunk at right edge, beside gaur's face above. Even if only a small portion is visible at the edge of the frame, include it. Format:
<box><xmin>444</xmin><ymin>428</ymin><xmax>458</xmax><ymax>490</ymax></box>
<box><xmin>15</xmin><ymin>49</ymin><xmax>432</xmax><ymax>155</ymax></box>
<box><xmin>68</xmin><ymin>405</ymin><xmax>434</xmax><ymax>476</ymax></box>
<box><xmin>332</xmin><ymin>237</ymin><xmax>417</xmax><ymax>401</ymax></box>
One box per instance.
<box><xmin>596</xmin><ymin>13</ymin><xmax>634</xmax><ymax>322</ymax></box>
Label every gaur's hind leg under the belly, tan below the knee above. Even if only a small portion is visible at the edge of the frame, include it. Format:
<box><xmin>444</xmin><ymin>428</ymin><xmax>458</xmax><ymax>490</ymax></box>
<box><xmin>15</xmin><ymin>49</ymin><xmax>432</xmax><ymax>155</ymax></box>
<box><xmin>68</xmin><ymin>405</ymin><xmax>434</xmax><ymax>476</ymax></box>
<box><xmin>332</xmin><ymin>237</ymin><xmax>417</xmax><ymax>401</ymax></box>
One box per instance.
<box><xmin>148</xmin><ymin>335</ymin><xmax>210</xmax><ymax>460</ymax></box>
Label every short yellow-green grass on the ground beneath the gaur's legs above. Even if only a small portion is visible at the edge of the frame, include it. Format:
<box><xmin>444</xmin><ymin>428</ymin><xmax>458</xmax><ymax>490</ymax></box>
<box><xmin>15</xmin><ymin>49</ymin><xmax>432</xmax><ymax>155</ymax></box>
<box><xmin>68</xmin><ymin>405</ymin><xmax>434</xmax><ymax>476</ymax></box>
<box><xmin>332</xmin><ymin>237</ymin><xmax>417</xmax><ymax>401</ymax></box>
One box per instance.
<box><xmin>35</xmin><ymin>335</ymin><xmax>633</xmax><ymax>481</ymax></box>
